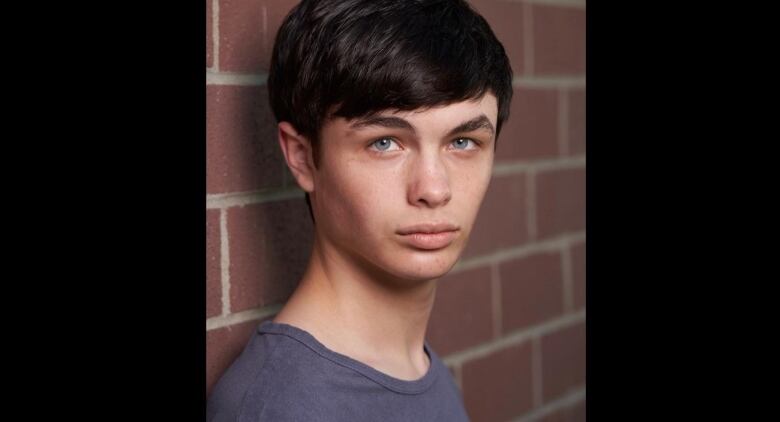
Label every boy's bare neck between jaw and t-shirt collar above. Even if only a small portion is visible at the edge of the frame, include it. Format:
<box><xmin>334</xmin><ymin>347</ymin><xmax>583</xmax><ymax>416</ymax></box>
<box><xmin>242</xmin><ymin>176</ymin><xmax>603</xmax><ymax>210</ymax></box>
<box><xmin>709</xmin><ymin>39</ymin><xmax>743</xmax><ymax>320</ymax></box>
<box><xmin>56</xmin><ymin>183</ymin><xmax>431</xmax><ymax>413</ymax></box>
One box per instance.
<box><xmin>274</xmin><ymin>234</ymin><xmax>437</xmax><ymax>379</ymax></box>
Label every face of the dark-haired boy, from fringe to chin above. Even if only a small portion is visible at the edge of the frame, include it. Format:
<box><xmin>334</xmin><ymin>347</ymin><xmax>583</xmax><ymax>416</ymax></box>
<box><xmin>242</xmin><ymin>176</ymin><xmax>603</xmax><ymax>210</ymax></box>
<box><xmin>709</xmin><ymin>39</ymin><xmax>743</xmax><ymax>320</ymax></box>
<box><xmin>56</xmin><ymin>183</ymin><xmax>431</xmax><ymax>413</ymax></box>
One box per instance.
<box><xmin>311</xmin><ymin>93</ymin><xmax>498</xmax><ymax>281</ymax></box>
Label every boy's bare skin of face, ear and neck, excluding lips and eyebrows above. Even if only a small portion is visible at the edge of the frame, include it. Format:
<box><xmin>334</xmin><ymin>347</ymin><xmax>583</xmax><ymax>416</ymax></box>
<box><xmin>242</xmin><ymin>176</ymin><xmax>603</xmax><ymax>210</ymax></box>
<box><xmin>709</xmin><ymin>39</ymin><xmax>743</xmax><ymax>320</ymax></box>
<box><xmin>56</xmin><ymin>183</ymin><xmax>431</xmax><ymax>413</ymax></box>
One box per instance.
<box><xmin>274</xmin><ymin>93</ymin><xmax>498</xmax><ymax>379</ymax></box>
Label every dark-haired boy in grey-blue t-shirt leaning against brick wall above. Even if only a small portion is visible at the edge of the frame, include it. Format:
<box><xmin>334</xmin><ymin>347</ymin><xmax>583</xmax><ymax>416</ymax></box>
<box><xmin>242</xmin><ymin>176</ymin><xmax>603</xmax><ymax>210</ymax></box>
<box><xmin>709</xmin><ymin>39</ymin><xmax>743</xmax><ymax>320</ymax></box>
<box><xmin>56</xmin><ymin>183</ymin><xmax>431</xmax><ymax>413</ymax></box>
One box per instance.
<box><xmin>208</xmin><ymin>0</ymin><xmax>512</xmax><ymax>422</ymax></box>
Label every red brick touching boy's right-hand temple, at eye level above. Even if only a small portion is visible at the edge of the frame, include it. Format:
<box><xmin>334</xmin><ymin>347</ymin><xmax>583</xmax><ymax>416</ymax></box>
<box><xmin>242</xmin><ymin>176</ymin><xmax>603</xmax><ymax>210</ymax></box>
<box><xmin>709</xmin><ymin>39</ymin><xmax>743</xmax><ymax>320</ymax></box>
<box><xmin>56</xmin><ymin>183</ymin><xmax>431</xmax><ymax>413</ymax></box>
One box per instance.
<box><xmin>496</xmin><ymin>88</ymin><xmax>559</xmax><ymax>161</ymax></box>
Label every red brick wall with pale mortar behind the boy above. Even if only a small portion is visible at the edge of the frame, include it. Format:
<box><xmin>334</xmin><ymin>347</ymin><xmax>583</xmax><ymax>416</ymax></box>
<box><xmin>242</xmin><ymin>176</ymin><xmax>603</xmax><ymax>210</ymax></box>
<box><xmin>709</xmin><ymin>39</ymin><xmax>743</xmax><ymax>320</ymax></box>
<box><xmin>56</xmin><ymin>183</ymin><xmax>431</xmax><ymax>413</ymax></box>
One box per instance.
<box><xmin>206</xmin><ymin>0</ymin><xmax>585</xmax><ymax>422</ymax></box>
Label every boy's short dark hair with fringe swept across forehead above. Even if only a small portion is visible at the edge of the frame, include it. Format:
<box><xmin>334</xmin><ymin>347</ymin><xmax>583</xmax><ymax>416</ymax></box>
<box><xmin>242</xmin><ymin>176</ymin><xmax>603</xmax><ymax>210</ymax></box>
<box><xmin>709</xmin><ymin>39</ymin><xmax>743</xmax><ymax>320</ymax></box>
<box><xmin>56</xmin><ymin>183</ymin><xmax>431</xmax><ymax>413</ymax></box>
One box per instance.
<box><xmin>268</xmin><ymin>0</ymin><xmax>512</xmax><ymax>141</ymax></box>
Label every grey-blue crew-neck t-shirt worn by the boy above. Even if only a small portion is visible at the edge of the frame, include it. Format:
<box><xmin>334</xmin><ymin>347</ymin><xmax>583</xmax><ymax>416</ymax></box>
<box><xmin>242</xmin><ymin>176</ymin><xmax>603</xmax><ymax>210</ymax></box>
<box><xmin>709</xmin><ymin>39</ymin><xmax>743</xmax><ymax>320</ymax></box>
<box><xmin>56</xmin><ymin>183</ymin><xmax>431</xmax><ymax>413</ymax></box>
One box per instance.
<box><xmin>206</xmin><ymin>320</ymin><xmax>469</xmax><ymax>422</ymax></box>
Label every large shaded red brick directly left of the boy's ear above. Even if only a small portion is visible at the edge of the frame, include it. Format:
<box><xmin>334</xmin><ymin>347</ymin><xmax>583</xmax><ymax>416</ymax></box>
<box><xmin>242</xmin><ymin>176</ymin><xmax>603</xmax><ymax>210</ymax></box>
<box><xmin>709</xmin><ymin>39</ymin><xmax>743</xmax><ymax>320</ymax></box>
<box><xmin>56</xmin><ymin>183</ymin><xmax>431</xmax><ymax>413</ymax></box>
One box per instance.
<box><xmin>206</xmin><ymin>85</ymin><xmax>286</xmax><ymax>193</ymax></box>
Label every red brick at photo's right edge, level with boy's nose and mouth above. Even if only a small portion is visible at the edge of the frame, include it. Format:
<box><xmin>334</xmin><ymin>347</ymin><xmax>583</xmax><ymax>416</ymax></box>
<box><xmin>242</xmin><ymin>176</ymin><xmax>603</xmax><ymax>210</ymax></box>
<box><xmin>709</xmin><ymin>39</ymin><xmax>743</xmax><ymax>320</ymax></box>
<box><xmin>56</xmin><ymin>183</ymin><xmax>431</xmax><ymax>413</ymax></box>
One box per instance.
<box><xmin>536</xmin><ymin>169</ymin><xmax>585</xmax><ymax>238</ymax></box>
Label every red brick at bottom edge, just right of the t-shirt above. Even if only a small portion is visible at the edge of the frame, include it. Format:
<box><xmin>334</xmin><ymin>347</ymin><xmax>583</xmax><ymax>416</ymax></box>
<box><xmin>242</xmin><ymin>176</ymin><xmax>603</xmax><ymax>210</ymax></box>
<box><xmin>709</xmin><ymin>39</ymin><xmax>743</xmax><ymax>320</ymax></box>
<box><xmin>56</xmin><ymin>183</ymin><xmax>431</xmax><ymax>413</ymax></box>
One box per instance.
<box><xmin>462</xmin><ymin>343</ymin><xmax>533</xmax><ymax>422</ymax></box>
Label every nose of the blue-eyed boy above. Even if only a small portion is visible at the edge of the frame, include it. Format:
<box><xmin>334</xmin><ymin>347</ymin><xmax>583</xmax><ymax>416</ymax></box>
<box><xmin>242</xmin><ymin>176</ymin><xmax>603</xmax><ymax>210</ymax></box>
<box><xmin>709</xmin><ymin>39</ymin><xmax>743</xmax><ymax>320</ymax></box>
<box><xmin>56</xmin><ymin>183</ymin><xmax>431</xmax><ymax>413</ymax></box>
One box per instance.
<box><xmin>408</xmin><ymin>153</ymin><xmax>452</xmax><ymax>208</ymax></box>
